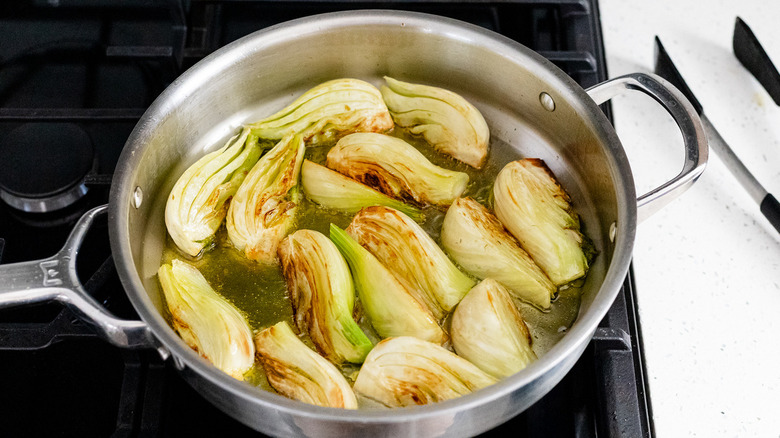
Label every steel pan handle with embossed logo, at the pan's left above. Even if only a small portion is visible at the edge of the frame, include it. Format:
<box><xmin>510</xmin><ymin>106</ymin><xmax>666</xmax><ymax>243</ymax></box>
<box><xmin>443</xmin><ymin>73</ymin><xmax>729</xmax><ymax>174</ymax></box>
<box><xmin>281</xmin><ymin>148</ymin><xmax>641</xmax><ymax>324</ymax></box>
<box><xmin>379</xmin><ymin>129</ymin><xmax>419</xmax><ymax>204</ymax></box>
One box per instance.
<box><xmin>0</xmin><ymin>205</ymin><xmax>157</xmax><ymax>348</ymax></box>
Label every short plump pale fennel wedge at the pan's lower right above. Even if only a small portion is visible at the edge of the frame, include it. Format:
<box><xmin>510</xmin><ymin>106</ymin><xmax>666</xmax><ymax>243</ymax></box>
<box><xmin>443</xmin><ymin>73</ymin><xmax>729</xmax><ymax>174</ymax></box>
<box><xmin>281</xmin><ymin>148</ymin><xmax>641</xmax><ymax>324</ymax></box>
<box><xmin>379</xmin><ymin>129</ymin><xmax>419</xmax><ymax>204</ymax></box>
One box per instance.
<box><xmin>450</xmin><ymin>278</ymin><xmax>536</xmax><ymax>379</ymax></box>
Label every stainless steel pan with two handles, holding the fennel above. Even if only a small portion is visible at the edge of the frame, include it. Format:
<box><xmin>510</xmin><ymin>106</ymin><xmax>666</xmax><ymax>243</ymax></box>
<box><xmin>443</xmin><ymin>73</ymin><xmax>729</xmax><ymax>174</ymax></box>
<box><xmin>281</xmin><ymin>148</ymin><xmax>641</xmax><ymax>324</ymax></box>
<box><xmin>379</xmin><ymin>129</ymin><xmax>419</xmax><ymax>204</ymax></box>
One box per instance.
<box><xmin>0</xmin><ymin>11</ymin><xmax>707</xmax><ymax>437</ymax></box>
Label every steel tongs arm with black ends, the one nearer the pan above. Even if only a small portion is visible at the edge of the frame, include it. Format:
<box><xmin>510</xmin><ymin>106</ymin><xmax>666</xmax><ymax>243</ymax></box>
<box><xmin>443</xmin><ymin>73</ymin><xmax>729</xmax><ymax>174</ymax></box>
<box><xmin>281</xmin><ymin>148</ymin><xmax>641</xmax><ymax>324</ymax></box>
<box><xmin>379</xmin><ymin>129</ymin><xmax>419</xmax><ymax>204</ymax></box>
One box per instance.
<box><xmin>655</xmin><ymin>36</ymin><xmax>780</xmax><ymax>232</ymax></box>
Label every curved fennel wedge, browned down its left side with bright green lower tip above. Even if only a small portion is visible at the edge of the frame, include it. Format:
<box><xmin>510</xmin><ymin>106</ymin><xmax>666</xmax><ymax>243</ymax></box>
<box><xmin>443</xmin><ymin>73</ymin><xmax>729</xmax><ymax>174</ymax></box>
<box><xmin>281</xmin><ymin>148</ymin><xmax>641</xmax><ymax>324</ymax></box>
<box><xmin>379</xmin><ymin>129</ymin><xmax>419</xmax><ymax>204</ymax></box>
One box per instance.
<box><xmin>278</xmin><ymin>230</ymin><xmax>374</xmax><ymax>364</ymax></box>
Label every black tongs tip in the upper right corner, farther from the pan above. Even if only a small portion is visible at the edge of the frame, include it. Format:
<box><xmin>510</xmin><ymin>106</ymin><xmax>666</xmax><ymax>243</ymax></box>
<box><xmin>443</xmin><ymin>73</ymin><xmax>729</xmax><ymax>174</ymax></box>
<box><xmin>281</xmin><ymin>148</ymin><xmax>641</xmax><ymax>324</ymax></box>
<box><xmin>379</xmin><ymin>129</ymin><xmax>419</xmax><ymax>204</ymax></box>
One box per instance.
<box><xmin>731</xmin><ymin>17</ymin><xmax>780</xmax><ymax>105</ymax></box>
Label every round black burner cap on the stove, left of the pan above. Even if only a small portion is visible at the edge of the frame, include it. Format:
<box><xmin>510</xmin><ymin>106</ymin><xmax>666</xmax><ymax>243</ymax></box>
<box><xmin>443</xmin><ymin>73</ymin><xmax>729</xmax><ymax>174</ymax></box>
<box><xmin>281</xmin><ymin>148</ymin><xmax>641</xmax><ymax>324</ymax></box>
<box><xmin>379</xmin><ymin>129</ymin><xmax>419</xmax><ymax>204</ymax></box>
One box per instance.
<box><xmin>0</xmin><ymin>122</ymin><xmax>95</xmax><ymax>212</ymax></box>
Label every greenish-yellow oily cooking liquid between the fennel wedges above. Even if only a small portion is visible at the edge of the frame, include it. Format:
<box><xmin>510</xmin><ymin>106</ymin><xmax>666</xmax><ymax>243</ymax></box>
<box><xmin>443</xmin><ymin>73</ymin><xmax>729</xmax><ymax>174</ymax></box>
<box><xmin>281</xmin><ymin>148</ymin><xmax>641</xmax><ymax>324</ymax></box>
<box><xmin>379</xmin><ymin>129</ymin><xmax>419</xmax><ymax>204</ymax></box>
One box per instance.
<box><xmin>161</xmin><ymin>128</ymin><xmax>587</xmax><ymax>398</ymax></box>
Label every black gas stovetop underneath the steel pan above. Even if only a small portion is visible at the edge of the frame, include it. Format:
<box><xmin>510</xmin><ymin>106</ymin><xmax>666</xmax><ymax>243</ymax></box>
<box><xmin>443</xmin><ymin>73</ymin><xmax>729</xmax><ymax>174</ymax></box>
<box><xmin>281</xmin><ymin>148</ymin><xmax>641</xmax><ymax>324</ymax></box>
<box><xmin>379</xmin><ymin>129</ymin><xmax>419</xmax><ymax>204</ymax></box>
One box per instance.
<box><xmin>0</xmin><ymin>0</ymin><xmax>652</xmax><ymax>437</ymax></box>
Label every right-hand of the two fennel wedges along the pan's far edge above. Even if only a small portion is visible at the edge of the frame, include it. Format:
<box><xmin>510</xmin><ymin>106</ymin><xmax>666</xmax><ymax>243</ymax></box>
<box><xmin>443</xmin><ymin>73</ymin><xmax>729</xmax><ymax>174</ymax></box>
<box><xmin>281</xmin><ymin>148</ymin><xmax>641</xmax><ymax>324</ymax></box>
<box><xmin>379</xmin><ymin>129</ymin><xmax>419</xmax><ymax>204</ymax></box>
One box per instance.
<box><xmin>381</xmin><ymin>76</ymin><xmax>490</xmax><ymax>169</ymax></box>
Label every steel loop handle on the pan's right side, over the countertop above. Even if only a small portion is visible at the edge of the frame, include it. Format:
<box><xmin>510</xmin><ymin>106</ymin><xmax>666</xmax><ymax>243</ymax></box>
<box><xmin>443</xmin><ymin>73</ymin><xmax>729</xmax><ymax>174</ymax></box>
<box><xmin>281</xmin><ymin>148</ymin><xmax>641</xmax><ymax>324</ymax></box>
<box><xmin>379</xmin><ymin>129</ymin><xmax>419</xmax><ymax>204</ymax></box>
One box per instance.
<box><xmin>587</xmin><ymin>73</ymin><xmax>709</xmax><ymax>222</ymax></box>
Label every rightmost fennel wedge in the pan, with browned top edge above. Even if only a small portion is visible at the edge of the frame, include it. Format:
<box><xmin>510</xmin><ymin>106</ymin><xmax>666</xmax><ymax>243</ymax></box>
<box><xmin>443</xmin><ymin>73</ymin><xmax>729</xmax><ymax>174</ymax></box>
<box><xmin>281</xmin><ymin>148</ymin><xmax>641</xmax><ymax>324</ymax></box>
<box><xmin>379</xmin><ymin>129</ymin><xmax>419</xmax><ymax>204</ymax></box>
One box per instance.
<box><xmin>493</xmin><ymin>158</ymin><xmax>588</xmax><ymax>286</ymax></box>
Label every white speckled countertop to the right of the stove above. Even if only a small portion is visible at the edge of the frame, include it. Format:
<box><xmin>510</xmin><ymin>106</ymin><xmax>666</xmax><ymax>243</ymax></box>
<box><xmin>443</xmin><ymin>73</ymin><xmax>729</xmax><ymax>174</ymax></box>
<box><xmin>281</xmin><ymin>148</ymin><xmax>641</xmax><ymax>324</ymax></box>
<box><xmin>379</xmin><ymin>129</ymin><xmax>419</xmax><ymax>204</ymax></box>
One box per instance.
<box><xmin>600</xmin><ymin>0</ymin><xmax>780</xmax><ymax>438</ymax></box>
